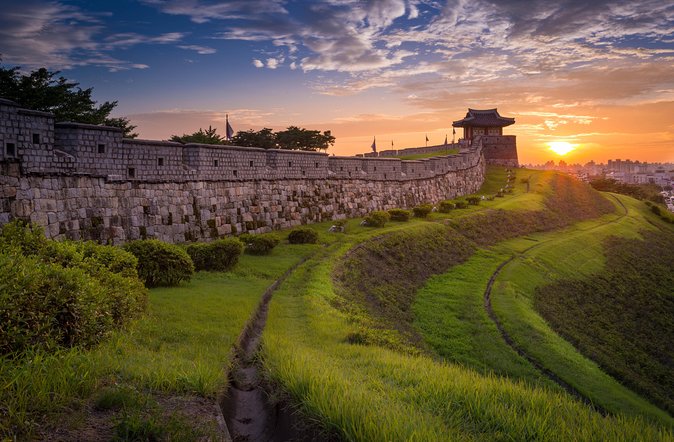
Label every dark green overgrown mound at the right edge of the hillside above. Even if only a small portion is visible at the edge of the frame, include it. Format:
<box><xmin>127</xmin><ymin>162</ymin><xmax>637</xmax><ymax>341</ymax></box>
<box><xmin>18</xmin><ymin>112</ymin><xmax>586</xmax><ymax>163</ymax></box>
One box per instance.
<box><xmin>534</xmin><ymin>231</ymin><xmax>674</xmax><ymax>414</ymax></box>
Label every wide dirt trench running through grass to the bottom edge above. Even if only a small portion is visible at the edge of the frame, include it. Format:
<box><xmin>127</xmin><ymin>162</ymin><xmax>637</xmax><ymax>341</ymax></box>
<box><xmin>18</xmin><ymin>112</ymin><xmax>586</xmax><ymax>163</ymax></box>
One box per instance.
<box><xmin>220</xmin><ymin>258</ymin><xmax>308</xmax><ymax>441</ymax></box>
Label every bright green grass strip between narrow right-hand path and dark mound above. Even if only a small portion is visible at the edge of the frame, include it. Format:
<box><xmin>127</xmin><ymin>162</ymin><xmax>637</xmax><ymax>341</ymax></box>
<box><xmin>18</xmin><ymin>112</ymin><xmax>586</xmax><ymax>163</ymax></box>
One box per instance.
<box><xmin>492</xmin><ymin>196</ymin><xmax>674</xmax><ymax>426</ymax></box>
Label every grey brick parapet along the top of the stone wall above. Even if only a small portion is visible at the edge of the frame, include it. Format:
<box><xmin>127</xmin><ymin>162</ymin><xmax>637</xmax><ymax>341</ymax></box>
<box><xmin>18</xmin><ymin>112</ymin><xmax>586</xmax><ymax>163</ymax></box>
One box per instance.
<box><xmin>0</xmin><ymin>99</ymin><xmax>484</xmax><ymax>182</ymax></box>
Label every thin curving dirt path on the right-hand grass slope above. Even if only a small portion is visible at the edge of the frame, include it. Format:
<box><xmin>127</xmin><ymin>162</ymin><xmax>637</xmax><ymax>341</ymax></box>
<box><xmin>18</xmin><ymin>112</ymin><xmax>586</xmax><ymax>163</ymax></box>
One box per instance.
<box><xmin>484</xmin><ymin>195</ymin><xmax>628</xmax><ymax>416</ymax></box>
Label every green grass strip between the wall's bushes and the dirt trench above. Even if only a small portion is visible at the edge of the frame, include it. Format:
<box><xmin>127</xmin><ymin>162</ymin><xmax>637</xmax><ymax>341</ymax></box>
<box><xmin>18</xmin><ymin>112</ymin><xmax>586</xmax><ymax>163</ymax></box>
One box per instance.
<box><xmin>0</xmin><ymin>245</ymin><xmax>316</xmax><ymax>434</ymax></box>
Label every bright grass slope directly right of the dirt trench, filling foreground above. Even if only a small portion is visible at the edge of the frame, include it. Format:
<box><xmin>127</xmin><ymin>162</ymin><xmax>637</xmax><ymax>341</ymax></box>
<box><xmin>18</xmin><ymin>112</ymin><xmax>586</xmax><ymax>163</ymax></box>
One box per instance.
<box><xmin>263</xmin><ymin>169</ymin><xmax>672</xmax><ymax>440</ymax></box>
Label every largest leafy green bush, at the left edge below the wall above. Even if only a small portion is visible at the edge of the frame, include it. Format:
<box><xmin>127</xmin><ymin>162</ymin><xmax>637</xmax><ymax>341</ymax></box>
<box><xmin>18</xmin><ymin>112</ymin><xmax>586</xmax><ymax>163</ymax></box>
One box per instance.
<box><xmin>0</xmin><ymin>222</ymin><xmax>147</xmax><ymax>354</ymax></box>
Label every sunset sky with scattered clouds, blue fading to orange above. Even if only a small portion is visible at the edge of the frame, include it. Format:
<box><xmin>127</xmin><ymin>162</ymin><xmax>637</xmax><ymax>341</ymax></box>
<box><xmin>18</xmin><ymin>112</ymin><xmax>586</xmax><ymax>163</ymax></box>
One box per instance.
<box><xmin>0</xmin><ymin>0</ymin><xmax>674</xmax><ymax>163</ymax></box>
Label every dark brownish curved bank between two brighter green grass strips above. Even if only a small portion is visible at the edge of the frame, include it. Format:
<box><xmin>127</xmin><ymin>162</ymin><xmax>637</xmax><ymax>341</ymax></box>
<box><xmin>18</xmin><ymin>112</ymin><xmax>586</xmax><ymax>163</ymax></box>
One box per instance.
<box><xmin>333</xmin><ymin>174</ymin><xmax>615</xmax><ymax>350</ymax></box>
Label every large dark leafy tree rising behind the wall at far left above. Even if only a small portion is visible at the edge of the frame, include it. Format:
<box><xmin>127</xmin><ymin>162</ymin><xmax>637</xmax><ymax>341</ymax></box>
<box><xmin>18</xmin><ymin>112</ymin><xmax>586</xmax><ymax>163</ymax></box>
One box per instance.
<box><xmin>0</xmin><ymin>66</ymin><xmax>138</xmax><ymax>138</ymax></box>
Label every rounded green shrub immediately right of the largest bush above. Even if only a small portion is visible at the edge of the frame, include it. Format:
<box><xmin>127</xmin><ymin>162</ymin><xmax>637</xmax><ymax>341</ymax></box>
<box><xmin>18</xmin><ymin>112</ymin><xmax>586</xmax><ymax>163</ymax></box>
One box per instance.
<box><xmin>124</xmin><ymin>239</ymin><xmax>194</xmax><ymax>287</ymax></box>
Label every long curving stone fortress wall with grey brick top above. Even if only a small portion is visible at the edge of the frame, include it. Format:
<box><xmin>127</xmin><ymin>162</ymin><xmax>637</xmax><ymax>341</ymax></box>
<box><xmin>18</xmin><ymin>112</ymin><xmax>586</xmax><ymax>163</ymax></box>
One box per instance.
<box><xmin>0</xmin><ymin>99</ymin><xmax>494</xmax><ymax>243</ymax></box>
